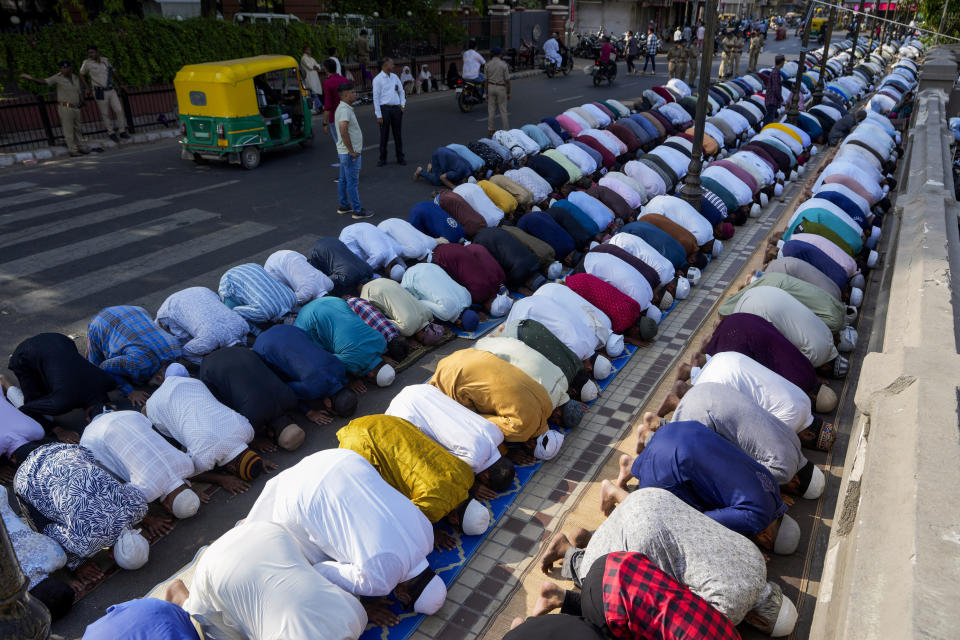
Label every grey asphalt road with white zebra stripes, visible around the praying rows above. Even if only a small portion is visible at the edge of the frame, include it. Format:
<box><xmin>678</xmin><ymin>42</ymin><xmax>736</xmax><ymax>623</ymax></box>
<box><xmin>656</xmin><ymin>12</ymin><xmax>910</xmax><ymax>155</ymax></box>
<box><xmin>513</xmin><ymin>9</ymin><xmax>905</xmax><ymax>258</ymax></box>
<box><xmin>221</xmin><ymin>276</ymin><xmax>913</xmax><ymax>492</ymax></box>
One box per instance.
<box><xmin>0</xmin><ymin>39</ymin><xmax>799</xmax><ymax>638</ymax></box>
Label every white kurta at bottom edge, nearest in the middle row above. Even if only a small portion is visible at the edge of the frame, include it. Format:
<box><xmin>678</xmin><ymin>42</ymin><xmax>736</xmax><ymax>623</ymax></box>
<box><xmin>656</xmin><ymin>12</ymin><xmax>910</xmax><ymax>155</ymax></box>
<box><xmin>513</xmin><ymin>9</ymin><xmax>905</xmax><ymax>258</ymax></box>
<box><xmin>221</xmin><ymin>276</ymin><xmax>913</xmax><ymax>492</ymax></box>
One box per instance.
<box><xmin>183</xmin><ymin>522</ymin><xmax>367</xmax><ymax>640</ymax></box>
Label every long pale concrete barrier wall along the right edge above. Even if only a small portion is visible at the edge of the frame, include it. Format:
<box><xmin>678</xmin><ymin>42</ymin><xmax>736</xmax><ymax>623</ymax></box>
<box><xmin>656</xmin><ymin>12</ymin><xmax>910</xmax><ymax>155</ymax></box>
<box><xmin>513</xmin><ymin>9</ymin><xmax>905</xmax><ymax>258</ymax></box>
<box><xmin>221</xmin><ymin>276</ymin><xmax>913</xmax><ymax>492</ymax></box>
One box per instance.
<box><xmin>810</xmin><ymin>54</ymin><xmax>960</xmax><ymax>640</ymax></box>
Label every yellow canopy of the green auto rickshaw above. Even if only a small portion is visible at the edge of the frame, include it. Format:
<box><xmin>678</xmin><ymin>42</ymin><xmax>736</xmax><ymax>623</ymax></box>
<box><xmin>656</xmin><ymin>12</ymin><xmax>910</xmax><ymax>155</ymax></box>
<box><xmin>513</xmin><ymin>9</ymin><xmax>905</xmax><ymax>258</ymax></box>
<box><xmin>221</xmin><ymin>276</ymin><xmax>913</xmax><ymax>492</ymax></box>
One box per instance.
<box><xmin>173</xmin><ymin>55</ymin><xmax>299</xmax><ymax>118</ymax></box>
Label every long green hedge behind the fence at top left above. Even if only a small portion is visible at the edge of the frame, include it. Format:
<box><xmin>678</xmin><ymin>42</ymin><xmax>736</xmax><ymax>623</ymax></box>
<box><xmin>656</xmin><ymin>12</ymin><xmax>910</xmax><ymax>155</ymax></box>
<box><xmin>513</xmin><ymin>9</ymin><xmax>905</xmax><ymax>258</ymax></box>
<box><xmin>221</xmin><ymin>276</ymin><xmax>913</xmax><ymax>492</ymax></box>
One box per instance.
<box><xmin>0</xmin><ymin>18</ymin><xmax>354</xmax><ymax>91</ymax></box>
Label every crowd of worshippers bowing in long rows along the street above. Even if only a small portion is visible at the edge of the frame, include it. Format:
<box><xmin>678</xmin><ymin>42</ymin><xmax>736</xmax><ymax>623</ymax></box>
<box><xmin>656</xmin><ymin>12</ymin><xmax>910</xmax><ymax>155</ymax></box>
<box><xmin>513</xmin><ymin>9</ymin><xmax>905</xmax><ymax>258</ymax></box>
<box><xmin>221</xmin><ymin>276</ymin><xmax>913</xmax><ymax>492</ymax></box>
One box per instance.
<box><xmin>0</xmin><ymin>33</ymin><xmax>916</xmax><ymax>640</ymax></box>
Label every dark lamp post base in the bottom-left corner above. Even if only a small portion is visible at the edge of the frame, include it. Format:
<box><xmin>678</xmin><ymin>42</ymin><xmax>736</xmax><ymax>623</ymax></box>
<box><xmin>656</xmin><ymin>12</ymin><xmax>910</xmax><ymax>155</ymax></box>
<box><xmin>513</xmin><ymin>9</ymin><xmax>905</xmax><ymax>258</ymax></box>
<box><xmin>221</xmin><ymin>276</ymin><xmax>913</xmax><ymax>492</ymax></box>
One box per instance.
<box><xmin>0</xmin><ymin>520</ymin><xmax>50</xmax><ymax>640</ymax></box>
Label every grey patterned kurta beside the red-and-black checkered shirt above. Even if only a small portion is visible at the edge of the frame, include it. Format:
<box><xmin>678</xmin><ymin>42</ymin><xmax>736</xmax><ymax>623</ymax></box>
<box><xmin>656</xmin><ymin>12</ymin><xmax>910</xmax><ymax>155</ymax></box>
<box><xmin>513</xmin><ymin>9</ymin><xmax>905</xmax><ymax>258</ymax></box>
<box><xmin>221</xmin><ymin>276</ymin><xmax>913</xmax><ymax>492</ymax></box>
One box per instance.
<box><xmin>579</xmin><ymin>488</ymin><xmax>767</xmax><ymax>624</ymax></box>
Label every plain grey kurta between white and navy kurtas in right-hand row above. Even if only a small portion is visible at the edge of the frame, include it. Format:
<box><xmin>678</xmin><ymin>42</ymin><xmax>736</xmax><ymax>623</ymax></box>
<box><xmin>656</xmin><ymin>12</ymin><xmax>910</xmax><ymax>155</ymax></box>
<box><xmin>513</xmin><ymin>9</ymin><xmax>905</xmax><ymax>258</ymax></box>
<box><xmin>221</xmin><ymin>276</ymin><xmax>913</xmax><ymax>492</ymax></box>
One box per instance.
<box><xmin>673</xmin><ymin>382</ymin><xmax>807</xmax><ymax>484</ymax></box>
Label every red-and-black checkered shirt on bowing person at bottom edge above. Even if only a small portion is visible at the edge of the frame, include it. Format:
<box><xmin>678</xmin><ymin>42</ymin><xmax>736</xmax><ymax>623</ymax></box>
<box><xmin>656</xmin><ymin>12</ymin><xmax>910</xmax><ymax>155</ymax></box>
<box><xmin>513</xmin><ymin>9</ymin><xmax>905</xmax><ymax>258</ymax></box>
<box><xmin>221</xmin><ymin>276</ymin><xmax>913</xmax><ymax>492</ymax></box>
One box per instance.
<box><xmin>603</xmin><ymin>551</ymin><xmax>740</xmax><ymax>640</ymax></box>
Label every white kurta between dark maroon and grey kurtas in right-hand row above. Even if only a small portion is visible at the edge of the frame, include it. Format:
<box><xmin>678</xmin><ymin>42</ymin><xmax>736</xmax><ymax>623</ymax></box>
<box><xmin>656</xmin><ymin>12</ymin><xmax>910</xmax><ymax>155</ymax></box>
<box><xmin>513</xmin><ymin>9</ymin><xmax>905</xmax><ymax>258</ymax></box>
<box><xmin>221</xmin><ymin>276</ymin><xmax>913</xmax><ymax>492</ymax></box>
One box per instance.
<box><xmin>693</xmin><ymin>351</ymin><xmax>813</xmax><ymax>432</ymax></box>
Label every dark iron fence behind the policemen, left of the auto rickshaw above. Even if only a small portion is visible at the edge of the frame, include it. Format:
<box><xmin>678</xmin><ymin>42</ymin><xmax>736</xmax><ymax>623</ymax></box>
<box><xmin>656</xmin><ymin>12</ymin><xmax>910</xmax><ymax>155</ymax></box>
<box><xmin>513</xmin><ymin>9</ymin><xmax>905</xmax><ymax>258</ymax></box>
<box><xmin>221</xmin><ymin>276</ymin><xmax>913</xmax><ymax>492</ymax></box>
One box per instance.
<box><xmin>0</xmin><ymin>85</ymin><xmax>178</xmax><ymax>152</ymax></box>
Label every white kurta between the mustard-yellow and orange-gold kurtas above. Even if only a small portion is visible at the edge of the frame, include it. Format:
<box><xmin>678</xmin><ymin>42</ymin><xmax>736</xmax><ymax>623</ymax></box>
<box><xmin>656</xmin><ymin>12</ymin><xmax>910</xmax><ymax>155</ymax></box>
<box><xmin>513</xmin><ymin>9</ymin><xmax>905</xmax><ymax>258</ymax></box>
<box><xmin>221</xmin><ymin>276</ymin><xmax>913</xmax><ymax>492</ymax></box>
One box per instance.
<box><xmin>384</xmin><ymin>384</ymin><xmax>503</xmax><ymax>473</ymax></box>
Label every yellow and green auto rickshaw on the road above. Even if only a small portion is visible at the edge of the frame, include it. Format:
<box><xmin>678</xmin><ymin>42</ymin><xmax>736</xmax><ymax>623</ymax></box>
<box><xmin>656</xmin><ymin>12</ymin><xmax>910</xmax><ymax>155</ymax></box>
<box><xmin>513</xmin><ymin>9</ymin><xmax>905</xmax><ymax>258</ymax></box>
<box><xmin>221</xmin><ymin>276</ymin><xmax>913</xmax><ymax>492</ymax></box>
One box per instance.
<box><xmin>173</xmin><ymin>55</ymin><xmax>313</xmax><ymax>169</ymax></box>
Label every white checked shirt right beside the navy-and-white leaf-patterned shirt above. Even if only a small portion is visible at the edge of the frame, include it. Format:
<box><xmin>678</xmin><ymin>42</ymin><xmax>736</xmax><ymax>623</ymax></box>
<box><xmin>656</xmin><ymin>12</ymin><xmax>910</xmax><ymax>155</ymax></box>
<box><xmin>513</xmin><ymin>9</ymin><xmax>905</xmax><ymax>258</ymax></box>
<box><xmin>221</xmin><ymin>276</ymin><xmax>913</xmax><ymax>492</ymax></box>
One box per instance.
<box><xmin>80</xmin><ymin>411</ymin><xmax>194</xmax><ymax>502</ymax></box>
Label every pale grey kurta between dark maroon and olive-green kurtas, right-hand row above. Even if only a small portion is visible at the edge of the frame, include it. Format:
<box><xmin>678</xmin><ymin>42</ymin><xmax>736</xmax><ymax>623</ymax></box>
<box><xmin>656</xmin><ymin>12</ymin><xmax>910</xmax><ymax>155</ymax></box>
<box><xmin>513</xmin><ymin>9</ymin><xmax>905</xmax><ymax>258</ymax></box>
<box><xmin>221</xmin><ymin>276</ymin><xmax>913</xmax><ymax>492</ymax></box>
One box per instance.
<box><xmin>731</xmin><ymin>287</ymin><xmax>840</xmax><ymax>367</ymax></box>
